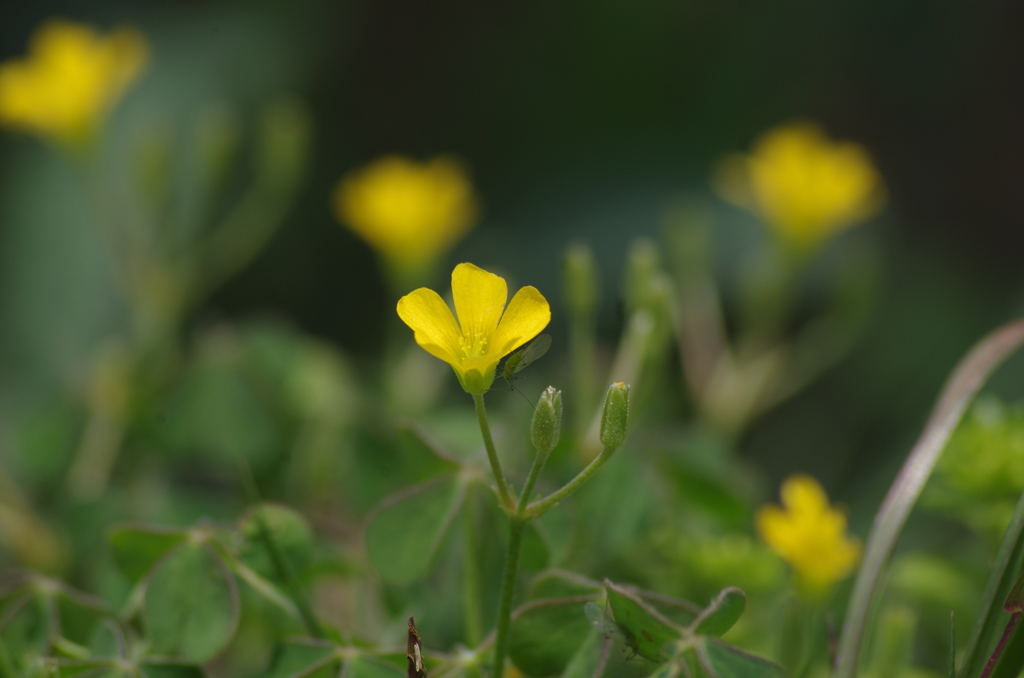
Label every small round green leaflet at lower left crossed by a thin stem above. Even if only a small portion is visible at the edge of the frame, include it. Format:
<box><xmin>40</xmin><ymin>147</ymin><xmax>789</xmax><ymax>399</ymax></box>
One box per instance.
<box><xmin>240</xmin><ymin>503</ymin><xmax>313</xmax><ymax>584</ymax></box>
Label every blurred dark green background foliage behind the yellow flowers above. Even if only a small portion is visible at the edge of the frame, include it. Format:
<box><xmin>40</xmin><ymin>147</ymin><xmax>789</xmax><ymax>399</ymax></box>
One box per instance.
<box><xmin>0</xmin><ymin>0</ymin><xmax>1024</xmax><ymax>675</ymax></box>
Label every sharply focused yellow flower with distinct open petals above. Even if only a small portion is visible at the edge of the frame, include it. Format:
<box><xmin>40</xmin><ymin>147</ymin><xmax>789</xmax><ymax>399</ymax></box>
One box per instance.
<box><xmin>398</xmin><ymin>263</ymin><xmax>551</xmax><ymax>395</ymax></box>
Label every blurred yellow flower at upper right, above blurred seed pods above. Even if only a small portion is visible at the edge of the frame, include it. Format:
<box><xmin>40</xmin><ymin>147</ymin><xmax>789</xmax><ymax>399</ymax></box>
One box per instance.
<box><xmin>715</xmin><ymin>122</ymin><xmax>885</xmax><ymax>248</ymax></box>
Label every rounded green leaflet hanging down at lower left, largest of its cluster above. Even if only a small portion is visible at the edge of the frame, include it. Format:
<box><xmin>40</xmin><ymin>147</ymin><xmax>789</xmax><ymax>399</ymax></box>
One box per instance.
<box><xmin>142</xmin><ymin>544</ymin><xmax>239</xmax><ymax>664</ymax></box>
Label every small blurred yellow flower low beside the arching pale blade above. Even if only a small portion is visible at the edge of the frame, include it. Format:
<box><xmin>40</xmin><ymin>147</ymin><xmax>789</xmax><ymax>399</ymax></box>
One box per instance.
<box><xmin>757</xmin><ymin>475</ymin><xmax>860</xmax><ymax>592</ymax></box>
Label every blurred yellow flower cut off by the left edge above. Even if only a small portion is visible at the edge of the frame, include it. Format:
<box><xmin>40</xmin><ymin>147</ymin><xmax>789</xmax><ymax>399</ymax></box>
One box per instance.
<box><xmin>0</xmin><ymin>19</ymin><xmax>148</xmax><ymax>145</ymax></box>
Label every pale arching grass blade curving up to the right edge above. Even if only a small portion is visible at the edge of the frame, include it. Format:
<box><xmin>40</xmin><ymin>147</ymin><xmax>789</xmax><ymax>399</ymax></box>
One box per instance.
<box><xmin>835</xmin><ymin>320</ymin><xmax>1024</xmax><ymax>678</ymax></box>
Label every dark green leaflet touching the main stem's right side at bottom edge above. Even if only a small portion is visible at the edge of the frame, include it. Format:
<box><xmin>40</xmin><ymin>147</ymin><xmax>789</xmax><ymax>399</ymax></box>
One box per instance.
<box><xmin>509</xmin><ymin>597</ymin><xmax>591</xmax><ymax>676</ymax></box>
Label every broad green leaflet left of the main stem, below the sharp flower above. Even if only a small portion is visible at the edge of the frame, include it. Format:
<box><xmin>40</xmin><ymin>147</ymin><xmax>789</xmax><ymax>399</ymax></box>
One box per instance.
<box><xmin>367</xmin><ymin>475</ymin><xmax>466</xmax><ymax>584</ymax></box>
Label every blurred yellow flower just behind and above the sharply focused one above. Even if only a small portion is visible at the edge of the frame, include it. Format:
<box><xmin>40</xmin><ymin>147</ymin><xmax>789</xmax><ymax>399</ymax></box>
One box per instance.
<box><xmin>334</xmin><ymin>156</ymin><xmax>477</xmax><ymax>271</ymax></box>
